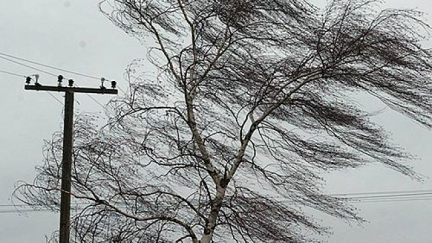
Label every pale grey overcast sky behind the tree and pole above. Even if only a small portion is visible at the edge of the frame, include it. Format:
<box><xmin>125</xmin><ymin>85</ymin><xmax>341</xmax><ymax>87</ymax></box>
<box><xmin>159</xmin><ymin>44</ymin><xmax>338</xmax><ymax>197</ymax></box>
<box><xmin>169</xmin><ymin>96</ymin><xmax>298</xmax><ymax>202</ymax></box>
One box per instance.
<box><xmin>0</xmin><ymin>0</ymin><xmax>432</xmax><ymax>243</ymax></box>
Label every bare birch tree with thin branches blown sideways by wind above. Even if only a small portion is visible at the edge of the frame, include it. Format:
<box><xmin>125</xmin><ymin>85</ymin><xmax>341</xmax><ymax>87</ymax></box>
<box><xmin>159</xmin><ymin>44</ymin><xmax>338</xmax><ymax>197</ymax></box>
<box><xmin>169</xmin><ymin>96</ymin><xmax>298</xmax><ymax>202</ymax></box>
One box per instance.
<box><xmin>17</xmin><ymin>0</ymin><xmax>432</xmax><ymax>243</ymax></box>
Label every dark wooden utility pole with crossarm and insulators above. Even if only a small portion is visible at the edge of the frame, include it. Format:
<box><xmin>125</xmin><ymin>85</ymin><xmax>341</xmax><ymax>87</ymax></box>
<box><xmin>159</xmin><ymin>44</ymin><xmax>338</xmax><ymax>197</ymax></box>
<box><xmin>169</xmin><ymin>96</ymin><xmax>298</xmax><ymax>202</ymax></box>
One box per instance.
<box><xmin>24</xmin><ymin>75</ymin><xmax>118</xmax><ymax>243</ymax></box>
